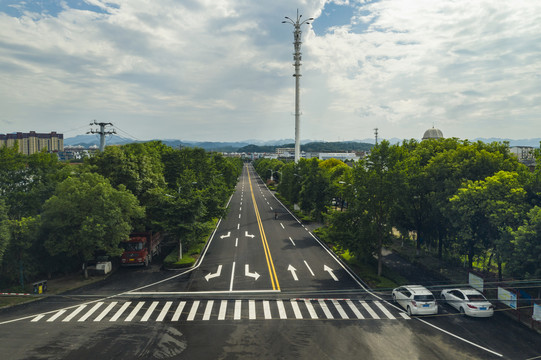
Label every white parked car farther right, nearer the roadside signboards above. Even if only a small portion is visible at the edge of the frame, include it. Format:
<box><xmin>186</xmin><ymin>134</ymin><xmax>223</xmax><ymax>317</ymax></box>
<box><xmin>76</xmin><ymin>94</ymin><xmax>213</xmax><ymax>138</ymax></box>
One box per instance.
<box><xmin>441</xmin><ymin>289</ymin><xmax>494</xmax><ymax>317</ymax></box>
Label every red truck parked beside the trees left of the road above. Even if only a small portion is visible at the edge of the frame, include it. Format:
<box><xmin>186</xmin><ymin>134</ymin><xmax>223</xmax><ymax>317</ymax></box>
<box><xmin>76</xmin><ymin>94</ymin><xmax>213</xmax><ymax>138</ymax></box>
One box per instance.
<box><xmin>121</xmin><ymin>232</ymin><xmax>162</xmax><ymax>266</ymax></box>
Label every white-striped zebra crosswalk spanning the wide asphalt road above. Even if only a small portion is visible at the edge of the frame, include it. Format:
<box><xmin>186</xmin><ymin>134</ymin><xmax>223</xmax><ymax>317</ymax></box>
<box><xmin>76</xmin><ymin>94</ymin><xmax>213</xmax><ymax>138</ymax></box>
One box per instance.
<box><xmin>30</xmin><ymin>299</ymin><xmax>410</xmax><ymax>323</ymax></box>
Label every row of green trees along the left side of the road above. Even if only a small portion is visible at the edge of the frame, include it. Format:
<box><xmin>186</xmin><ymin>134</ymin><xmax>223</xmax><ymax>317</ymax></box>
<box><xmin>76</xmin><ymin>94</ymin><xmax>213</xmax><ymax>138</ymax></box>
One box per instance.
<box><xmin>0</xmin><ymin>142</ymin><xmax>242</xmax><ymax>285</ymax></box>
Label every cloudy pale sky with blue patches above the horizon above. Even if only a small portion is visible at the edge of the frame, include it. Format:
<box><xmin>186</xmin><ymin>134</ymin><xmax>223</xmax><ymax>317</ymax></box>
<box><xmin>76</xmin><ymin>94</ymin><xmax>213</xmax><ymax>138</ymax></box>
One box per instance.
<box><xmin>0</xmin><ymin>0</ymin><xmax>541</xmax><ymax>141</ymax></box>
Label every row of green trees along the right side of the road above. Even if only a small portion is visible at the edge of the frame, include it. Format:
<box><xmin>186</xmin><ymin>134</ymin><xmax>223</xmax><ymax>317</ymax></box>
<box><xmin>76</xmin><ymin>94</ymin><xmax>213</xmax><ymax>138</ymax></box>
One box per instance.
<box><xmin>256</xmin><ymin>139</ymin><xmax>541</xmax><ymax>278</ymax></box>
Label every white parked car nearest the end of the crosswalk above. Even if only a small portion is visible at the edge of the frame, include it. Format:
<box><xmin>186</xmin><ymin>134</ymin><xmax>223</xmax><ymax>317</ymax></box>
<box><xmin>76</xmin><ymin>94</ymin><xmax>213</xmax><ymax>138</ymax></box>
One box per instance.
<box><xmin>393</xmin><ymin>285</ymin><xmax>438</xmax><ymax>315</ymax></box>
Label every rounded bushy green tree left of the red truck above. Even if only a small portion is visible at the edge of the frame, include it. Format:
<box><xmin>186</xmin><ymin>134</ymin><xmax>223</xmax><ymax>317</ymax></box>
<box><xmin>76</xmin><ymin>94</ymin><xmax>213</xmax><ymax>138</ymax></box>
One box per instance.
<box><xmin>42</xmin><ymin>173</ymin><xmax>144</xmax><ymax>270</ymax></box>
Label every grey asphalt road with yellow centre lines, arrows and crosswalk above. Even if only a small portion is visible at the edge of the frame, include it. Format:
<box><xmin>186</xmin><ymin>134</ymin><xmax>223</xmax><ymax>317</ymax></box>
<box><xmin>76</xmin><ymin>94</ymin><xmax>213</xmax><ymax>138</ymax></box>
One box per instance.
<box><xmin>0</xmin><ymin>165</ymin><xmax>541</xmax><ymax>359</ymax></box>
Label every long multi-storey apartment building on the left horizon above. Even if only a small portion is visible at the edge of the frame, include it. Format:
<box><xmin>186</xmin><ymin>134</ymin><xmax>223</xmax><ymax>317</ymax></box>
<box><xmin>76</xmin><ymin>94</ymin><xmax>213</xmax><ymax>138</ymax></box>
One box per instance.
<box><xmin>0</xmin><ymin>131</ymin><xmax>64</xmax><ymax>155</ymax></box>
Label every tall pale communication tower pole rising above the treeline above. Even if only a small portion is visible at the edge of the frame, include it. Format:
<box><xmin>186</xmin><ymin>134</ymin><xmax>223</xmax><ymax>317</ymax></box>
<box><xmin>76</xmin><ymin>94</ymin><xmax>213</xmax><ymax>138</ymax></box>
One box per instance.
<box><xmin>282</xmin><ymin>9</ymin><xmax>314</xmax><ymax>162</ymax></box>
